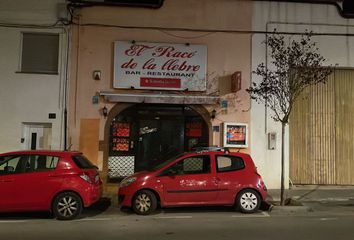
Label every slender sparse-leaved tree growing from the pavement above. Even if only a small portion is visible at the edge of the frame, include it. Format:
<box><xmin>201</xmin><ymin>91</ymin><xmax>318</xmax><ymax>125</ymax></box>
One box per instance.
<box><xmin>247</xmin><ymin>31</ymin><xmax>332</xmax><ymax>205</ymax></box>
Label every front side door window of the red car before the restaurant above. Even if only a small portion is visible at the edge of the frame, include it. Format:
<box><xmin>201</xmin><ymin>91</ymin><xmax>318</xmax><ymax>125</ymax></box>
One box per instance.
<box><xmin>167</xmin><ymin>156</ymin><xmax>210</xmax><ymax>175</ymax></box>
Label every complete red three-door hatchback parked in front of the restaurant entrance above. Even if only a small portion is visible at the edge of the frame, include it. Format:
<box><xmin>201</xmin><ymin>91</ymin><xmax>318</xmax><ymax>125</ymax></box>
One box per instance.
<box><xmin>118</xmin><ymin>149</ymin><xmax>267</xmax><ymax>215</ymax></box>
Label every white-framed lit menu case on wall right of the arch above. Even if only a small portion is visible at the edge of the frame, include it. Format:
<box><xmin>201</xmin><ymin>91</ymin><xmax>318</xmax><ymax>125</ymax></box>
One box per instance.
<box><xmin>223</xmin><ymin>123</ymin><xmax>248</xmax><ymax>148</ymax></box>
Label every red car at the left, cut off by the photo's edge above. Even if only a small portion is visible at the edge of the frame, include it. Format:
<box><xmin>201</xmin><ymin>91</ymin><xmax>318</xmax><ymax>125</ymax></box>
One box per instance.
<box><xmin>0</xmin><ymin>151</ymin><xmax>102</xmax><ymax>220</ymax></box>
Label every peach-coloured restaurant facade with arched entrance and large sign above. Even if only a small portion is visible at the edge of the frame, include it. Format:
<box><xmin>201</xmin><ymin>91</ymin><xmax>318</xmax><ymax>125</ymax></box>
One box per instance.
<box><xmin>69</xmin><ymin>0</ymin><xmax>252</xmax><ymax>189</ymax></box>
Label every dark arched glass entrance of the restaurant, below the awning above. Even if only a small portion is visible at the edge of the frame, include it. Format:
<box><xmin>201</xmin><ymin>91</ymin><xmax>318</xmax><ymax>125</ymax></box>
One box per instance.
<box><xmin>108</xmin><ymin>104</ymin><xmax>209</xmax><ymax>181</ymax></box>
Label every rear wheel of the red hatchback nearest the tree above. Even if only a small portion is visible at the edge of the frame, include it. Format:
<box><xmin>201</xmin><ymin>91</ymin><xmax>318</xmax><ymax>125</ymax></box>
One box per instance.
<box><xmin>236</xmin><ymin>189</ymin><xmax>261</xmax><ymax>213</ymax></box>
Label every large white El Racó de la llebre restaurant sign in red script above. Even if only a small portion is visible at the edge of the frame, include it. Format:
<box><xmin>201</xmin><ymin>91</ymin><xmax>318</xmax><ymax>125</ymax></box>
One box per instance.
<box><xmin>113</xmin><ymin>41</ymin><xmax>207</xmax><ymax>91</ymax></box>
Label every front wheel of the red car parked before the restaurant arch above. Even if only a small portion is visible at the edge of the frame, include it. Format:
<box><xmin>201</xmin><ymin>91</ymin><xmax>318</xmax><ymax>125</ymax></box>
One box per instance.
<box><xmin>133</xmin><ymin>190</ymin><xmax>157</xmax><ymax>215</ymax></box>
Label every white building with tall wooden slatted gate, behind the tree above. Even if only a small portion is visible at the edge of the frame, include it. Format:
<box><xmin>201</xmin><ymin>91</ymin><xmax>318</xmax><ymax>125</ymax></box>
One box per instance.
<box><xmin>251</xmin><ymin>1</ymin><xmax>354</xmax><ymax>188</ymax></box>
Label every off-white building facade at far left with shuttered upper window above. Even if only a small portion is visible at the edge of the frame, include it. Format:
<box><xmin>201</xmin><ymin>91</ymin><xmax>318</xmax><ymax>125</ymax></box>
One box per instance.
<box><xmin>0</xmin><ymin>0</ymin><xmax>68</xmax><ymax>152</ymax></box>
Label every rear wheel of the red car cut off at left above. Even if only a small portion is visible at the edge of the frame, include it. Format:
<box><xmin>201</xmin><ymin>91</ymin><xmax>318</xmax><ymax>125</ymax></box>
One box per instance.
<box><xmin>53</xmin><ymin>192</ymin><xmax>83</xmax><ymax>220</ymax></box>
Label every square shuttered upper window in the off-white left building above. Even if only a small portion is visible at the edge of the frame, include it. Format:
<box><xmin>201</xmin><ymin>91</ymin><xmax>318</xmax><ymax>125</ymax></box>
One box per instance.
<box><xmin>21</xmin><ymin>33</ymin><xmax>59</xmax><ymax>74</ymax></box>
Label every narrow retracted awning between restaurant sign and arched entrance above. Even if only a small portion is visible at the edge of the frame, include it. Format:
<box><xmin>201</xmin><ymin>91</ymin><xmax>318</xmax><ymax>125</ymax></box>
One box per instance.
<box><xmin>100</xmin><ymin>91</ymin><xmax>220</xmax><ymax>104</ymax></box>
